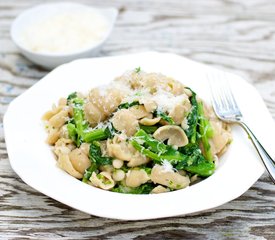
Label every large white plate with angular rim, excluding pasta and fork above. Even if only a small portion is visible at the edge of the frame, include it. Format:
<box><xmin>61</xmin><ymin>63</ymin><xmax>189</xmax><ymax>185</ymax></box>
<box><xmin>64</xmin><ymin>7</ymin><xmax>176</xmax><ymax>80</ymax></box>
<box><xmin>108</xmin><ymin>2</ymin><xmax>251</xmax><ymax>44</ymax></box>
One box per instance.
<box><xmin>4</xmin><ymin>52</ymin><xmax>275</xmax><ymax>220</ymax></box>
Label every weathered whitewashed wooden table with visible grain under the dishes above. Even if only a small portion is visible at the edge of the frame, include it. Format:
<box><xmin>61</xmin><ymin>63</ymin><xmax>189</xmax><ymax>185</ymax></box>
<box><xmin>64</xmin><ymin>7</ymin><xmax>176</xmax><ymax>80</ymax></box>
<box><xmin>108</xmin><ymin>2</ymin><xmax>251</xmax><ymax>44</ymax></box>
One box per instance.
<box><xmin>0</xmin><ymin>0</ymin><xmax>275</xmax><ymax>239</ymax></box>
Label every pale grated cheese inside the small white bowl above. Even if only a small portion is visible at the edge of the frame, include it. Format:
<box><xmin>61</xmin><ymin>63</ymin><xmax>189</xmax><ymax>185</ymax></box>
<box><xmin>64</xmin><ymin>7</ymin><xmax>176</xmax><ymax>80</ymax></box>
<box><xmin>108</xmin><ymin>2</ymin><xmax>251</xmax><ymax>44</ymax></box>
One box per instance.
<box><xmin>21</xmin><ymin>11</ymin><xmax>108</xmax><ymax>53</ymax></box>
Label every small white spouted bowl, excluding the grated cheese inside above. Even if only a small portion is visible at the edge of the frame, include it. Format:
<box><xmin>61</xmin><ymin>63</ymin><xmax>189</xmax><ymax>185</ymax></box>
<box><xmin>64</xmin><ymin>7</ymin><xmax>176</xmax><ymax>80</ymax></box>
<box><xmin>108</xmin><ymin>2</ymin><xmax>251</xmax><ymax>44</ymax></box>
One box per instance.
<box><xmin>11</xmin><ymin>2</ymin><xmax>118</xmax><ymax>69</ymax></box>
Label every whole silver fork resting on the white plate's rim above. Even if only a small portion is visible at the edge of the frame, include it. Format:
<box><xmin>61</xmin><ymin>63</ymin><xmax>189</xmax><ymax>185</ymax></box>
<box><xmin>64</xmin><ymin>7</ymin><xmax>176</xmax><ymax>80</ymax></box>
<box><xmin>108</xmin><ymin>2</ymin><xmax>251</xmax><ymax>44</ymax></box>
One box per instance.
<box><xmin>208</xmin><ymin>73</ymin><xmax>275</xmax><ymax>183</ymax></box>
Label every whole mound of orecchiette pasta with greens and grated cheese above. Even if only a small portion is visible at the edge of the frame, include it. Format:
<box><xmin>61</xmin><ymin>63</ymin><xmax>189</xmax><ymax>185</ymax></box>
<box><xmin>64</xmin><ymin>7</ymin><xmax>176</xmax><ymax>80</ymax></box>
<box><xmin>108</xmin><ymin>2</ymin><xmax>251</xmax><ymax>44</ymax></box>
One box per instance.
<box><xmin>42</xmin><ymin>68</ymin><xmax>231</xmax><ymax>194</ymax></box>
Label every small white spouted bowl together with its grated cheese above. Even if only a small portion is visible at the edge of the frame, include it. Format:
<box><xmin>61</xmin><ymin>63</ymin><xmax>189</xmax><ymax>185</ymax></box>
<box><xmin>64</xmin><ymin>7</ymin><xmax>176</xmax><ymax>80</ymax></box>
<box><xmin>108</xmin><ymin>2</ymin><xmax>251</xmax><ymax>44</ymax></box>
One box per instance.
<box><xmin>11</xmin><ymin>2</ymin><xmax>118</xmax><ymax>69</ymax></box>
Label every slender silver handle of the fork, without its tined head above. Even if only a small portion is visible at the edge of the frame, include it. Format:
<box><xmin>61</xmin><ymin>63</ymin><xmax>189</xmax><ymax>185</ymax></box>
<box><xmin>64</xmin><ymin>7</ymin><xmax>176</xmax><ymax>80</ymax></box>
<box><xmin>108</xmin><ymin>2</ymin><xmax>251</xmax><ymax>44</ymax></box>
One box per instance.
<box><xmin>239</xmin><ymin>121</ymin><xmax>275</xmax><ymax>183</ymax></box>
